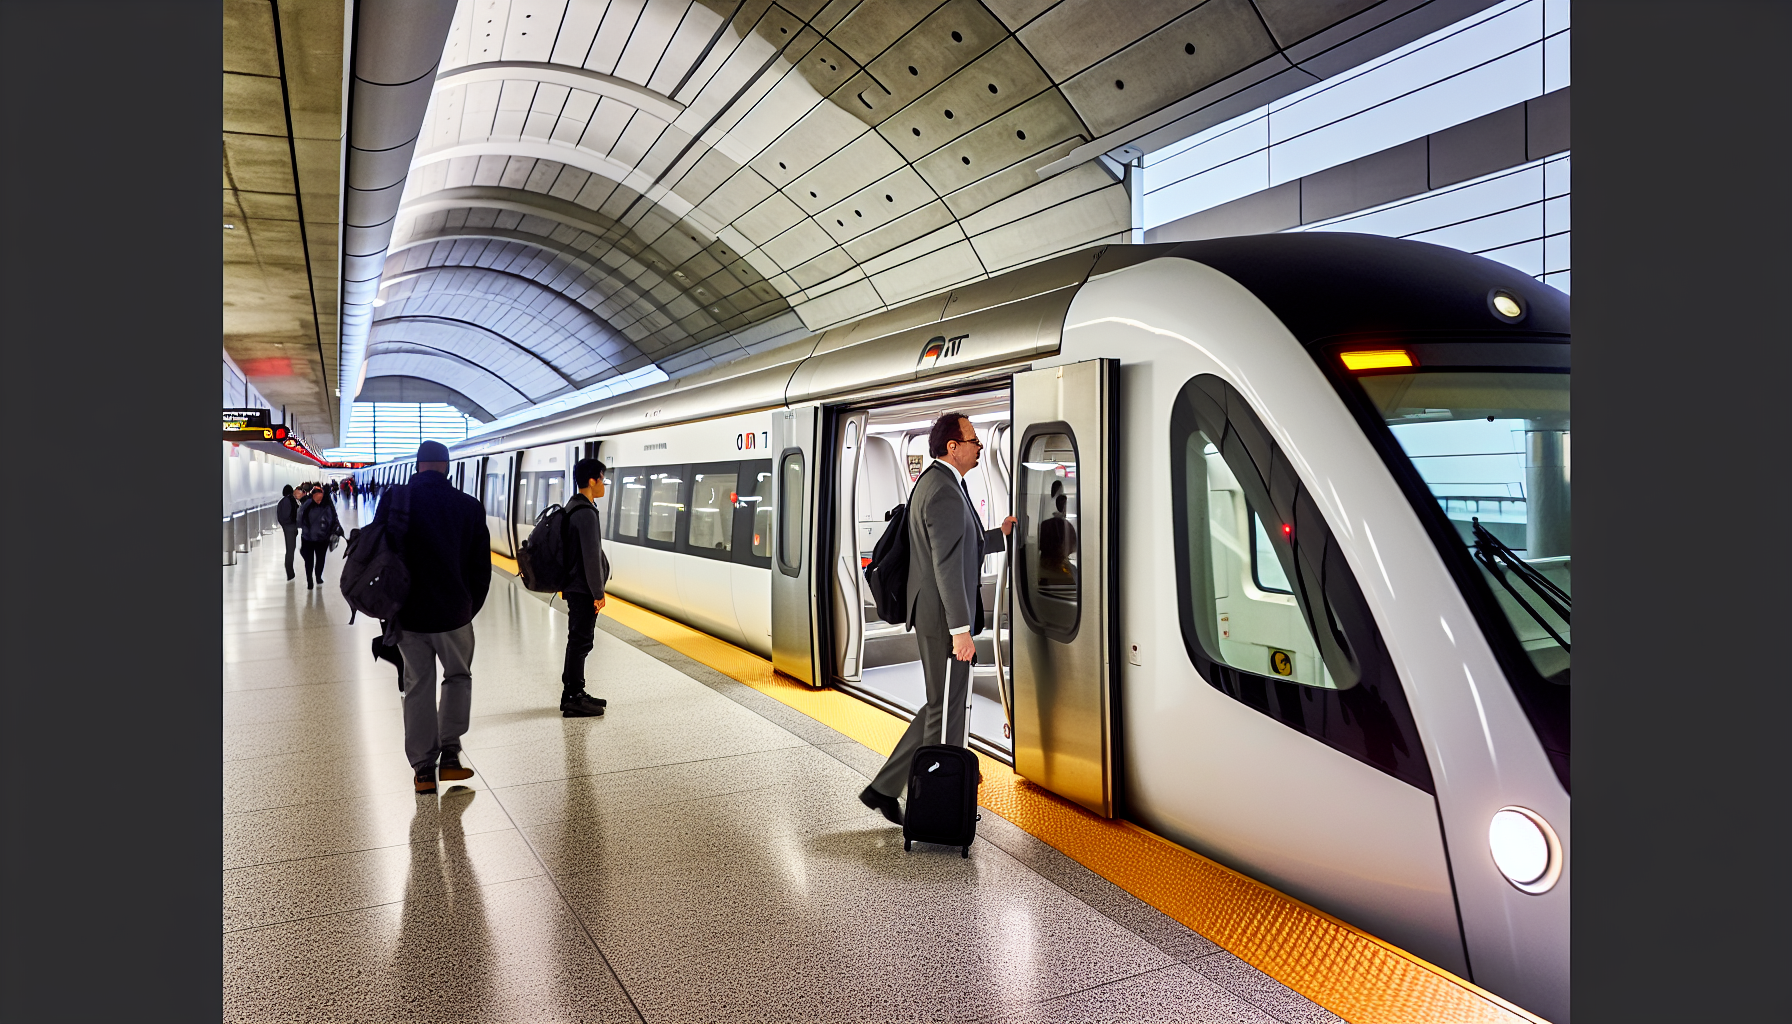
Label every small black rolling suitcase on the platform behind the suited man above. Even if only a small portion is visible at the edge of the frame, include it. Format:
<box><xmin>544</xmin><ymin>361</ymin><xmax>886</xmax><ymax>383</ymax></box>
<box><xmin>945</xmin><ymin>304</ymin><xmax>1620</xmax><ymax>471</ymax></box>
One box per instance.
<box><xmin>901</xmin><ymin>658</ymin><xmax>984</xmax><ymax>857</ymax></box>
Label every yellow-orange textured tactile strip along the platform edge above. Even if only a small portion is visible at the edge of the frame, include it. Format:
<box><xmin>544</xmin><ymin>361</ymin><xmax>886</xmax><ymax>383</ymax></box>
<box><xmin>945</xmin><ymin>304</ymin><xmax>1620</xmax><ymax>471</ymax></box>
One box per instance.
<box><xmin>493</xmin><ymin>570</ymin><xmax>1546</xmax><ymax>1024</ymax></box>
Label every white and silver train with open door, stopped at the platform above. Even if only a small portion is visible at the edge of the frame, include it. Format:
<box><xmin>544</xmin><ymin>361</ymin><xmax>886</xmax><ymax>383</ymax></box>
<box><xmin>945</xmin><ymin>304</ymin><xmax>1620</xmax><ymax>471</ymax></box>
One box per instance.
<box><xmin>357</xmin><ymin>231</ymin><xmax>1573</xmax><ymax>1022</ymax></box>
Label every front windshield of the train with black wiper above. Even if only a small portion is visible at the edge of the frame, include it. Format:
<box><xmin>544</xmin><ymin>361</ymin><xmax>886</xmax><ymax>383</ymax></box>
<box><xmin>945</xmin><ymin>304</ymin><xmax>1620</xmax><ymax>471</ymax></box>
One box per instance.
<box><xmin>1358</xmin><ymin>369</ymin><xmax>1573</xmax><ymax>687</ymax></box>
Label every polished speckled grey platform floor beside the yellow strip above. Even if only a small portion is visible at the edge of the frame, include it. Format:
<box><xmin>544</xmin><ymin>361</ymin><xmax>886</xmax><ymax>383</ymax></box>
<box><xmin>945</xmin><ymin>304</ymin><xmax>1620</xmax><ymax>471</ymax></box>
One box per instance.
<box><xmin>222</xmin><ymin>509</ymin><xmax>1337</xmax><ymax>1024</ymax></box>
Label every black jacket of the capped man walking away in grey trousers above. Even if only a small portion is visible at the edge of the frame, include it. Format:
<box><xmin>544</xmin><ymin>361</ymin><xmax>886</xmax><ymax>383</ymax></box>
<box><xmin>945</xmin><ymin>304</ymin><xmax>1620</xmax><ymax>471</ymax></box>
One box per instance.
<box><xmin>373</xmin><ymin>470</ymin><xmax>491</xmax><ymax>633</ymax></box>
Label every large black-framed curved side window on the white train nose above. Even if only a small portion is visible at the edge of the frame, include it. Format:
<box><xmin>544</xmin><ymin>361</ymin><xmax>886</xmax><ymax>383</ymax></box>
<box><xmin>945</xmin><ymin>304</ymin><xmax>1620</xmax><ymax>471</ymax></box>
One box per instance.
<box><xmin>1170</xmin><ymin>375</ymin><xmax>1435</xmax><ymax>793</ymax></box>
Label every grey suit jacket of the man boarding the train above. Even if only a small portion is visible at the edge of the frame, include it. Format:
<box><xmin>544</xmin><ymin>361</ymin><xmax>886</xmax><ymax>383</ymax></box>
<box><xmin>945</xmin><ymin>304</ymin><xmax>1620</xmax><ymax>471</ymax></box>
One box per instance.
<box><xmin>909</xmin><ymin>459</ymin><xmax>1002</xmax><ymax>629</ymax></box>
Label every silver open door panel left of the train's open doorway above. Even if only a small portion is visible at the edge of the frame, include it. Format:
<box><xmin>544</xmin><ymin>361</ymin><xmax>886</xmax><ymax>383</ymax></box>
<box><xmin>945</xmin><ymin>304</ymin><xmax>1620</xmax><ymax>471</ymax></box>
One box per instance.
<box><xmin>772</xmin><ymin>405</ymin><xmax>823</xmax><ymax>687</ymax></box>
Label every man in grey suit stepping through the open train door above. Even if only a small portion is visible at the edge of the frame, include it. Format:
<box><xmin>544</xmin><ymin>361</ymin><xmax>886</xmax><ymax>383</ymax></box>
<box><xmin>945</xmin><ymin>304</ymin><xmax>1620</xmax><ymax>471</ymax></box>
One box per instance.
<box><xmin>858</xmin><ymin>412</ymin><xmax>1014</xmax><ymax>825</ymax></box>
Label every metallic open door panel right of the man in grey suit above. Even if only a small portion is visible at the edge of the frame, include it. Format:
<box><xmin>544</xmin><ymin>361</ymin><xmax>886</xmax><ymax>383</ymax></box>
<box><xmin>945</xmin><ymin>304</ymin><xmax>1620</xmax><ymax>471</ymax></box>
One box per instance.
<box><xmin>1011</xmin><ymin>359</ymin><xmax>1120</xmax><ymax>818</ymax></box>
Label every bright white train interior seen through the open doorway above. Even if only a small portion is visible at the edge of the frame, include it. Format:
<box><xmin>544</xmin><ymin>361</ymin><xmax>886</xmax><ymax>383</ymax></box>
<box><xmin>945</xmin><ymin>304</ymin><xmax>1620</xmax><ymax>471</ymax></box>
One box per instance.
<box><xmin>833</xmin><ymin>387</ymin><xmax>1012</xmax><ymax>759</ymax></box>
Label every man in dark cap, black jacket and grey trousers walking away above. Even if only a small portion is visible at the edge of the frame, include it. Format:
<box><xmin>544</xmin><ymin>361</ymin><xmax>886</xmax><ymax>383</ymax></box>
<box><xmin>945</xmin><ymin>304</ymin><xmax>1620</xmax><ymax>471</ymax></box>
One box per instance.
<box><xmin>373</xmin><ymin>441</ymin><xmax>491</xmax><ymax>794</ymax></box>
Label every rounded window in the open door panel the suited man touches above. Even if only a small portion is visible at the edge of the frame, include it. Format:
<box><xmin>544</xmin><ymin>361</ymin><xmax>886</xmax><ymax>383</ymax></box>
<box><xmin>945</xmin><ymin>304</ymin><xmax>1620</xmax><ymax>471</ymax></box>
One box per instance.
<box><xmin>1014</xmin><ymin>423</ymin><xmax>1082</xmax><ymax>644</ymax></box>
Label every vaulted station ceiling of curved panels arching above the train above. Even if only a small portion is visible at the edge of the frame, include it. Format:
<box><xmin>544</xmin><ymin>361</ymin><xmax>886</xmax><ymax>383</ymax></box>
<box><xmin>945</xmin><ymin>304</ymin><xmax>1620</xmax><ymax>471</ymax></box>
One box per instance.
<box><xmin>342</xmin><ymin>0</ymin><xmax>1489</xmax><ymax>432</ymax></box>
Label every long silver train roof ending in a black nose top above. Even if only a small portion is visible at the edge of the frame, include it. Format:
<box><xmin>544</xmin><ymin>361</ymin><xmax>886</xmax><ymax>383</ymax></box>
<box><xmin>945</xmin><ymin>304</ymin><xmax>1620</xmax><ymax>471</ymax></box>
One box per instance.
<box><xmin>433</xmin><ymin>231</ymin><xmax>1570</xmax><ymax>457</ymax></box>
